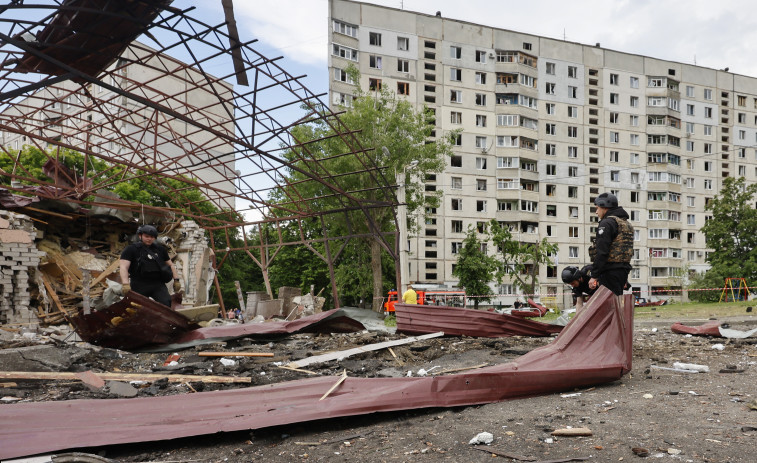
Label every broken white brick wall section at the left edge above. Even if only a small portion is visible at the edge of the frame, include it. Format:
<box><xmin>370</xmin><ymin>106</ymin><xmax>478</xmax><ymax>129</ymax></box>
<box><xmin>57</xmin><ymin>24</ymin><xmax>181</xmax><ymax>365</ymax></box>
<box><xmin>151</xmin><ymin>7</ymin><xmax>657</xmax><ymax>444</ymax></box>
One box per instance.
<box><xmin>0</xmin><ymin>211</ymin><xmax>45</xmax><ymax>325</ymax></box>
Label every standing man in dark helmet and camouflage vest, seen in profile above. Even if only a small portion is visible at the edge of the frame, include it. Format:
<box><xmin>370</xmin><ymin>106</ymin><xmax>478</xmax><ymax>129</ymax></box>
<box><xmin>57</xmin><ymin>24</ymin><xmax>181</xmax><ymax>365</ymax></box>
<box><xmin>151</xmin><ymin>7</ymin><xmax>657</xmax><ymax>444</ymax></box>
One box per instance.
<box><xmin>589</xmin><ymin>193</ymin><xmax>634</xmax><ymax>296</ymax></box>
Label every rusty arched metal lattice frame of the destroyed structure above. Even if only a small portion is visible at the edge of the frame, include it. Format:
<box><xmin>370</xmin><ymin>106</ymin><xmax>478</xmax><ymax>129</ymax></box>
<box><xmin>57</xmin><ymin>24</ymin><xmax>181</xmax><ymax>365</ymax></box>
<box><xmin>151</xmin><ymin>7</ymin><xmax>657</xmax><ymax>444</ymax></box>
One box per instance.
<box><xmin>0</xmin><ymin>0</ymin><xmax>399</xmax><ymax>307</ymax></box>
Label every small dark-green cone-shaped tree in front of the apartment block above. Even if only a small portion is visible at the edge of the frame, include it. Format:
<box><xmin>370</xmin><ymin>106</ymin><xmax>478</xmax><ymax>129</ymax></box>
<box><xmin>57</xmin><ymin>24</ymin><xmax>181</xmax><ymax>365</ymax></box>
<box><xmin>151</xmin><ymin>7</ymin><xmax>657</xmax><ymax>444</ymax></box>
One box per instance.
<box><xmin>452</xmin><ymin>227</ymin><xmax>497</xmax><ymax>309</ymax></box>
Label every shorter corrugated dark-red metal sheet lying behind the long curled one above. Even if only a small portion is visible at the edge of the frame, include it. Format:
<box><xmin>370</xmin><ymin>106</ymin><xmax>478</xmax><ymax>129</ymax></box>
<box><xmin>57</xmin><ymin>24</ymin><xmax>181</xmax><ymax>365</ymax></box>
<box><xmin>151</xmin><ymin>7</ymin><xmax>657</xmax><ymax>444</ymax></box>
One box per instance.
<box><xmin>394</xmin><ymin>303</ymin><xmax>563</xmax><ymax>338</ymax></box>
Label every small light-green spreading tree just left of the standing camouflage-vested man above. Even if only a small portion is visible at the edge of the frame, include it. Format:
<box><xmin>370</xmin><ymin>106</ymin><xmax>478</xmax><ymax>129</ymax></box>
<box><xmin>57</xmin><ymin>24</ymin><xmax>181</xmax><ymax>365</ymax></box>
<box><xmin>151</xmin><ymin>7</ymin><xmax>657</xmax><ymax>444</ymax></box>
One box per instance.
<box><xmin>489</xmin><ymin>219</ymin><xmax>558</xmax><ymax>294</ymax></box>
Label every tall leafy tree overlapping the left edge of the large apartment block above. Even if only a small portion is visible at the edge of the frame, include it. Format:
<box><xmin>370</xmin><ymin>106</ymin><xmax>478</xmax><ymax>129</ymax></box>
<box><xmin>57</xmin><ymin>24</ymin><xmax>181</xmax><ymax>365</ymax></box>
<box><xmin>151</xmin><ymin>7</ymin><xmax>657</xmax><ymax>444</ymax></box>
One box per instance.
<box><xmin>271</xmin><ymin>67</ymin><xmax>457</xmax><ymax>310</ymax></box>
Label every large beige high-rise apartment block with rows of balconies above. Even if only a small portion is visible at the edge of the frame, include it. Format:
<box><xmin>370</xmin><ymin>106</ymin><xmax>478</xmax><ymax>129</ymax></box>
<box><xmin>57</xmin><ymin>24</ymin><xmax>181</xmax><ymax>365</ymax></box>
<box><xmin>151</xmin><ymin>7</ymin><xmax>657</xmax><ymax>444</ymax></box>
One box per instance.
<box><xmin>329</xmin><ymin>0</ymin><xmax>757</xmax><ymax>303</ymax></box>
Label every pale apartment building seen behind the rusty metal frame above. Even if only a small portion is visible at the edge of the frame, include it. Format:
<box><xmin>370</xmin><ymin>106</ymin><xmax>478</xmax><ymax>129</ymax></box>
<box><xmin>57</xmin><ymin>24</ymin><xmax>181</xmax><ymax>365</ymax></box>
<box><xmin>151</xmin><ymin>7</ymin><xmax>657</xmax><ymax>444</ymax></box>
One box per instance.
<box><xmin>0</xmin><ymin>42</ymin><xmax>237</xmax><ymax>209</ymax></box>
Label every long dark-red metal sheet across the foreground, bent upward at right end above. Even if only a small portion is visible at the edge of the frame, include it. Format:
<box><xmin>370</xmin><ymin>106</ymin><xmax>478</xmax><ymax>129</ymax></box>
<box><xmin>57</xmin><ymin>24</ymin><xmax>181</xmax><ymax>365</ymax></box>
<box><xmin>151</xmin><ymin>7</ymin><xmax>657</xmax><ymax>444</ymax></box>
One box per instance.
<box><xmin>0</xmin><ymin>287</ymin><xmax>633</xmax><ymax>458</ymax></box>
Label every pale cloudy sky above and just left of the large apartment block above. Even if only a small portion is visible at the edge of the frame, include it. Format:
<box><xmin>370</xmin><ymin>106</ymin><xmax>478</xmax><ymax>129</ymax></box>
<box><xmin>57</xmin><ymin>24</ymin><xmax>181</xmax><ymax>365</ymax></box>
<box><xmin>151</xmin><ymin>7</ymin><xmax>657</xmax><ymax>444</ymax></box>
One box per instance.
<box><xmin>210</xmin><ymin>0</ymin><xmax>757</xmax><ymax>93</ymax></box>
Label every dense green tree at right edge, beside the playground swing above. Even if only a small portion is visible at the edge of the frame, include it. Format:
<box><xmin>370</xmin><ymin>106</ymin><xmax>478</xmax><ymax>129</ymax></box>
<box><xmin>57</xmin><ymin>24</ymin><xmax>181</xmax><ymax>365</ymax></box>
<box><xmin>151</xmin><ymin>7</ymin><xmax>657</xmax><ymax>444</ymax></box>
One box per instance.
<box><xmin>701</xmin><ymin>177</ymin><xmax>757</xmax><ymax>286</ymax></box>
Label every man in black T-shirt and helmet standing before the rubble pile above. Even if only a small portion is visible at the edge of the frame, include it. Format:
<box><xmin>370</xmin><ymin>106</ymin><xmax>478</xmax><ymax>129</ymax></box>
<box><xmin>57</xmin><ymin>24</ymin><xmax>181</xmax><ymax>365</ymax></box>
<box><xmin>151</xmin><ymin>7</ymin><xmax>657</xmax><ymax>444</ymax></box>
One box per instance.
<box><xmin>119</xmin><ymin>225</ymin><xmax>181</xmax><ymax>307</ymax></box>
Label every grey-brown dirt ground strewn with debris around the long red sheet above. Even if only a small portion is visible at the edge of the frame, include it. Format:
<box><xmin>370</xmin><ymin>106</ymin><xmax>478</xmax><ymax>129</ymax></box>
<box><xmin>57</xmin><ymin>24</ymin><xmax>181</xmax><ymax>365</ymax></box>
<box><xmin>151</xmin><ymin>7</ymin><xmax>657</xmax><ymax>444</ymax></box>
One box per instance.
<box><xmin>0</xmin><ymin>316</ymin><xmax>757</xmax><ymax>463</ymax></box>
